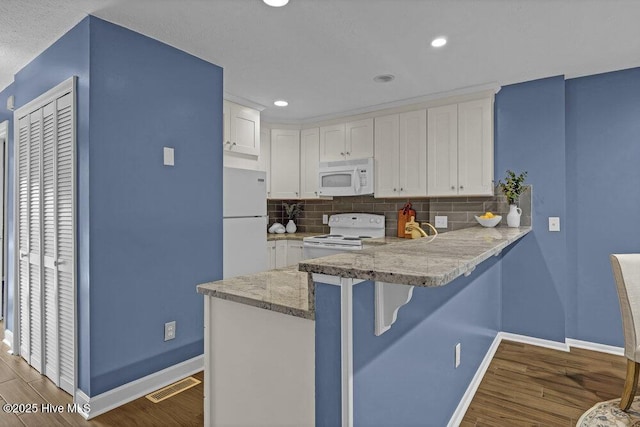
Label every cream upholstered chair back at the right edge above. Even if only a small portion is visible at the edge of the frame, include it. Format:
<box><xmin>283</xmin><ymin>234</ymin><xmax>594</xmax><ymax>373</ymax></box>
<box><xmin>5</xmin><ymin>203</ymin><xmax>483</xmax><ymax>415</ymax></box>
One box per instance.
<box><xmin>609</xmin><ymin>254</ymin><xmax>640</xmax><ymax>362</ymax></box>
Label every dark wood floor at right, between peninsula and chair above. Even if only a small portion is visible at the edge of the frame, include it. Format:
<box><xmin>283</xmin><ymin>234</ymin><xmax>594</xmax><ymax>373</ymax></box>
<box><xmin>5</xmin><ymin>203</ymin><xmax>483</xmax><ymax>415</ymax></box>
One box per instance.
<box><xmin>460</xmin><ymin>341</ymin><xmax>626</xmax><ymax>427</ymax></box>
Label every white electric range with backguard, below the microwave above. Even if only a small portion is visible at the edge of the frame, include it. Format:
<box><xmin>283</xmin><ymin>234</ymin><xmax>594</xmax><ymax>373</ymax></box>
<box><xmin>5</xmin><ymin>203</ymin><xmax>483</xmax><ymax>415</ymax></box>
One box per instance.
<box><xmin>303</xmin><ymin>213</ymin><xmax>385</xmax><ymax>259</ymax></box>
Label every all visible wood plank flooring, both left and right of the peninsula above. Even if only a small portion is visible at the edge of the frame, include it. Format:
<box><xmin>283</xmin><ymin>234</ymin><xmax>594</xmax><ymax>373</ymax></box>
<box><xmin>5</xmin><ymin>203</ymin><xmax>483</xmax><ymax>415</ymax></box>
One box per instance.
<box><xmin>0</xmin><ymin>322</ymin><xmax>626</xmax><ymax>427</ymax></box>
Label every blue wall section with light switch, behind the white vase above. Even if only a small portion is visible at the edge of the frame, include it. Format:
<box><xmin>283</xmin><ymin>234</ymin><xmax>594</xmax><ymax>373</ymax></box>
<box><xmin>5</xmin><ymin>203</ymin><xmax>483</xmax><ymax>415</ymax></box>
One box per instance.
<box><xmin>495</xmin><ymin>77</ymin><xmax>571</xmax><ymax>341</ymax></box>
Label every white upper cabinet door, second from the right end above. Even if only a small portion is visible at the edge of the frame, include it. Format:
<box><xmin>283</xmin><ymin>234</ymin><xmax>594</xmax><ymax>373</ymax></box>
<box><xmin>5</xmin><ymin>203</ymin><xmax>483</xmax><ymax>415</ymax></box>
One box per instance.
<box><xmin>427</xmin><ymin>104</ymin><xmax>458</xmax><ymax>196</ymax></box>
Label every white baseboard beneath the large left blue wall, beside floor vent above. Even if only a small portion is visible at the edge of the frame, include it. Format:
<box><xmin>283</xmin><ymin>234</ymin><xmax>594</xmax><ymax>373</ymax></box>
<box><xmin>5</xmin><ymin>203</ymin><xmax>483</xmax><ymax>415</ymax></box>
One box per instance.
<box><xmin>75</xmin><ymin>355</ymin><xmax>204</xmax><ymax>419</ymax></box>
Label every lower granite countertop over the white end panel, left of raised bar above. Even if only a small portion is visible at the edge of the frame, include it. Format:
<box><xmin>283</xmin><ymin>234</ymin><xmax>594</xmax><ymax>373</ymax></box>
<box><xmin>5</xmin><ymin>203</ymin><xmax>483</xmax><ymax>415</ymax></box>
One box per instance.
<box><xmin>197</xmin><ymin>266</ymin><xmax>315</xmax><ymax>320</ymax></box>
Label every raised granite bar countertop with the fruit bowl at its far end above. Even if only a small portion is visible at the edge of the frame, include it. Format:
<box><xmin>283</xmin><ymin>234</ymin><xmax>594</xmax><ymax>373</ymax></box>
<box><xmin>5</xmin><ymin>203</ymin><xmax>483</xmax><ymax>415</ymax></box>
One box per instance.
<box><xmin>298</xmin><ymin>226</ymin><xmax>531</xmax><ymax>286</ymax></box>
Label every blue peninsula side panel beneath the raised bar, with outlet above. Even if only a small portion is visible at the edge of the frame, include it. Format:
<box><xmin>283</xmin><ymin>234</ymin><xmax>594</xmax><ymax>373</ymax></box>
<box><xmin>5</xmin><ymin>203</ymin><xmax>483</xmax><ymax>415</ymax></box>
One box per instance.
<box><xmin>316</xmin><ymin>258</ymin><xmax>501</xmax><ymax>427</ymax></box>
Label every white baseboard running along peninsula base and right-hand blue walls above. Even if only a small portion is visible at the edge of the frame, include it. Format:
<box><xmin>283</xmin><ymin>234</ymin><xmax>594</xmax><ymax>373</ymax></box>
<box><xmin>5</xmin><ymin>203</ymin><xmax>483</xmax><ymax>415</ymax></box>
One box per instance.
<box><xmin>447</xmin><ymin>332</ymin><xmax>624</xmax><ymax>427</ymax></box>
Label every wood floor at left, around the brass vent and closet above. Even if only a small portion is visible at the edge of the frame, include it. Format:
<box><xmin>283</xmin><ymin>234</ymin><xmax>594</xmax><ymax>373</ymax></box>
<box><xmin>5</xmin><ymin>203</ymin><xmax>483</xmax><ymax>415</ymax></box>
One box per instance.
<box><xmin>0</xmin><ymin>322</ymin><xmax>204</xmax><ymax>427</ymax></box>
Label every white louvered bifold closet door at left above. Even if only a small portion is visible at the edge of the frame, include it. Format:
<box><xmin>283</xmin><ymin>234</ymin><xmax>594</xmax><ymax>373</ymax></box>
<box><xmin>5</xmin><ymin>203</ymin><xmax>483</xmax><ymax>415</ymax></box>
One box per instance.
<box><xmin>17</xmin><ymin>78</ymin><xmax>75</xmax><ymax>394</ymax></box>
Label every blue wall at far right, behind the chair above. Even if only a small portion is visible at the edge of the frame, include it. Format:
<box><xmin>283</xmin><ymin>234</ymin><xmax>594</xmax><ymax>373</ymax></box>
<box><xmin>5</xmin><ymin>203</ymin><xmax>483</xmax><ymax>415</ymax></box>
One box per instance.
<box><xmin>566</xmin><ymin>68</ymin><xmax>640</xmax><ymax>346</ymax></box>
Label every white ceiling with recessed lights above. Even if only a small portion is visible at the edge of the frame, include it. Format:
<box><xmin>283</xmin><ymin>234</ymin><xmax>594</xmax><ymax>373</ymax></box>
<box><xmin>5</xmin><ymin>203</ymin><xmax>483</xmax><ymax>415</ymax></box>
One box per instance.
<box><xmin>0</xmin><ymin>0</ymin><xmax>640</xmax><ymax>123</ymax></box>
